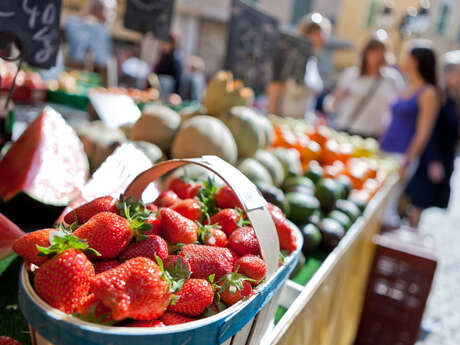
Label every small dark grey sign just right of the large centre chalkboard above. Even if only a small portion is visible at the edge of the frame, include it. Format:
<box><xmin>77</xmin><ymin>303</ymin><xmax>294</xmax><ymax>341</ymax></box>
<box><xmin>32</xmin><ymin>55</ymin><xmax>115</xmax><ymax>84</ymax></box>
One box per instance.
<box><xmin>274</xmin><ymin>29</ymin><xmax>313</xmax><ymax>84</ymax></box>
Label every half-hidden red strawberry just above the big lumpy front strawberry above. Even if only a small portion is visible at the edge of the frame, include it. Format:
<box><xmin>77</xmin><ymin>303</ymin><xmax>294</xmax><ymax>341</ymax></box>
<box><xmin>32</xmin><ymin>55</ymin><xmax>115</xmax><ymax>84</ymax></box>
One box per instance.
<box><xmin>119</xmin><ymin>235</ymin><xmax>168</xmax><ymax>260</ymax></box>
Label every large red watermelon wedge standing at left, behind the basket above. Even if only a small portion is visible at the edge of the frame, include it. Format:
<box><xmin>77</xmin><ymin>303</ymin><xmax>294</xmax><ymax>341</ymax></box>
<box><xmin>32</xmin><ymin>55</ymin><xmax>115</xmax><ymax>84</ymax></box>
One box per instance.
<box><xmin>0</xmin><ymin>107</ymin><xmax>88</xmax><ymax>228</ymax></box>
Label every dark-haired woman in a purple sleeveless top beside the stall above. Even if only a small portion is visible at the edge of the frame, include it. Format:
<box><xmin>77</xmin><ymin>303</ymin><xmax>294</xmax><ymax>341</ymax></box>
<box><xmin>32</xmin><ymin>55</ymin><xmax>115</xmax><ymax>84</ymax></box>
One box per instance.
<box><xmin>381</xmin><ymin>41</ymin><xmax>440</xmax><ymax>226</ymax></box>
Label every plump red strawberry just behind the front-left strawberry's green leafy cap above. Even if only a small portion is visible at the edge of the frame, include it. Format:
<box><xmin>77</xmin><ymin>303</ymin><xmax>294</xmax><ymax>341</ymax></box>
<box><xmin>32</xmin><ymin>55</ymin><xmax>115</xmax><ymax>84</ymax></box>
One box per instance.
<box><xmin>73</xmin><ymin>212</ymin><xmax>133</xmax><ymax>259</ymax></box>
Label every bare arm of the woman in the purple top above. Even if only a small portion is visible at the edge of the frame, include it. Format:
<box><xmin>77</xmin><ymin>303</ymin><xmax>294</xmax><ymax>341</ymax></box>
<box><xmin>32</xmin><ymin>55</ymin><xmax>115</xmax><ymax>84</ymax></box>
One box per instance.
<box><xmin>406</xmin><ymin>87</ymin><xmax>439</xmax><ymax>162</ymax></box>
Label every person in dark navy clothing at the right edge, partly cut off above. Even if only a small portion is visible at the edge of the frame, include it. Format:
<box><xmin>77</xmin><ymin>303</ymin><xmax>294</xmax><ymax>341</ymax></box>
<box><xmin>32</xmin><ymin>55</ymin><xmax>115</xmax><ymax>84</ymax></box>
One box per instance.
<box><xmin>406</xmin><ymin>53</ymin><xmax>460</xmax><ymax>227</ymax></box>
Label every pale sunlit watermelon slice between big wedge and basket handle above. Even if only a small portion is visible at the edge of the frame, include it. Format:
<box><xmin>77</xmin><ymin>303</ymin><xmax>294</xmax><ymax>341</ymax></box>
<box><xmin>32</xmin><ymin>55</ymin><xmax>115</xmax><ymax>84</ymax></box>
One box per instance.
<box><xmin>58</xmin><ymin>143</ymin><xmax>152</xmax><ymax>222</ymax></box>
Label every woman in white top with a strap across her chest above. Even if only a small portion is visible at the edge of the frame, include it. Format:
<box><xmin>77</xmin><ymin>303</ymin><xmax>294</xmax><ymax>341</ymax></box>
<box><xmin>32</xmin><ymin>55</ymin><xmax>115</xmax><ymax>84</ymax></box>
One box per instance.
<box><xmin>325</xmin><ymin>38</ymin><xmax>404</xmax><ymax>138</ymax></box>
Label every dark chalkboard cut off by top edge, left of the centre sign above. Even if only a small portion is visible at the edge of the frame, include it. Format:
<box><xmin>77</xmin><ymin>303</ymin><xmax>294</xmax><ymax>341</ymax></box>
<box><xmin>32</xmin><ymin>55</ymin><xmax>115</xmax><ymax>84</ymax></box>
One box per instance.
<box><xmin>124</xmin><ymin>0</ymin><xmax>174</xmax><ymax>39</ymax></box>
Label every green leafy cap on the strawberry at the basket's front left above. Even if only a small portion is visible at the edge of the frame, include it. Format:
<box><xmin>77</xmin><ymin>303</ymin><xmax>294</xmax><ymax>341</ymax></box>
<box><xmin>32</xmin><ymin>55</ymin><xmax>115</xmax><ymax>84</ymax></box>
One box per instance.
<box><xmin>37</xmin><ymin>223</ymin><xmax>101</xmax><ymax>257</ymax></box>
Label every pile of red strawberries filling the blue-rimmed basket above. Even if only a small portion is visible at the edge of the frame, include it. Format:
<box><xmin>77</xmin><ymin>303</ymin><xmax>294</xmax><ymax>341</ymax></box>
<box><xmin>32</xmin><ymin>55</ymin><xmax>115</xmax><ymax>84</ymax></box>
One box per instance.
<box><xmin>13</xmin><ymin>178</ymin><xmax>296</xmax><ymax>327</ymax></box>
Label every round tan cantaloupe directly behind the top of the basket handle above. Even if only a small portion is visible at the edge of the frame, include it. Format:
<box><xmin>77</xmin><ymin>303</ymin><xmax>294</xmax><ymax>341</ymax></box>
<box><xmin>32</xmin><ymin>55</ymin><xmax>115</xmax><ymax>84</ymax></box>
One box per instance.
<box><xmin>171</xmin><ymin>115</ymin><xmax>238</xmax><ymax>164</ymax></box>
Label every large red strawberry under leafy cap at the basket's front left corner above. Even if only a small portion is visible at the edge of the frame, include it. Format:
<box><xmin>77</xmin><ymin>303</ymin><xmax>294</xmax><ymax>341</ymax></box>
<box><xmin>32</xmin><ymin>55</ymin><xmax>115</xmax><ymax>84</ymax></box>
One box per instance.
<box><xmin>34</xmin><ymin>248</ymin><xmax>94</xmax><ymax>313</ymax></box>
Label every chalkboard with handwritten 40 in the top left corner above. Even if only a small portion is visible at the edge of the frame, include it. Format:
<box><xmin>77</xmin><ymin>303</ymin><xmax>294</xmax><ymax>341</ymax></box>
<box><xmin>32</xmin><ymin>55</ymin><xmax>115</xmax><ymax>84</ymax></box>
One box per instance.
<box><xmin>0</xmin><ymin>0</ymin><xmax>61</xmax><ymax>68</ymax></box>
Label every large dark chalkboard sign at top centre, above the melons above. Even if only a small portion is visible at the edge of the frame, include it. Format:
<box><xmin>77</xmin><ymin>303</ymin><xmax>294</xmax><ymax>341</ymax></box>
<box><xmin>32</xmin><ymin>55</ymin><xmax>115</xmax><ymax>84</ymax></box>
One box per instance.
<box><xmin>226</xmin><ymin>0</ymin><xmax>278</xmax><ymax>92</ymax></box>
